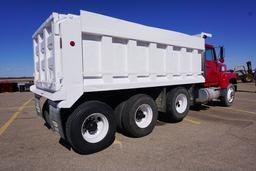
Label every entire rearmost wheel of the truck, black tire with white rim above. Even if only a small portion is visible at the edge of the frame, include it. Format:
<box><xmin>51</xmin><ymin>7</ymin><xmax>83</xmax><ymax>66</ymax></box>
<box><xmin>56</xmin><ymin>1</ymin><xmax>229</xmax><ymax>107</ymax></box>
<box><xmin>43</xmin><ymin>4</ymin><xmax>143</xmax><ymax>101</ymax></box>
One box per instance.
<box><xmin>66</xmin><ymin>101</ymin><xmax>116</xmax><ymax>154</ymax></box>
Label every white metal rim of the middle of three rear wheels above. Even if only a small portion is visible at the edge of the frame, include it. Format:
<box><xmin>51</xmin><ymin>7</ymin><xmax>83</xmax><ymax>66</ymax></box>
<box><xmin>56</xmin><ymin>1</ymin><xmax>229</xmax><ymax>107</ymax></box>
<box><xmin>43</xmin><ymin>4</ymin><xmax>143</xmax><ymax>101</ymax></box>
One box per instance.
<box><xmin>134</xmin><ymin>104</ymin><xmax>153</xmax><ymax>128</ymax></box>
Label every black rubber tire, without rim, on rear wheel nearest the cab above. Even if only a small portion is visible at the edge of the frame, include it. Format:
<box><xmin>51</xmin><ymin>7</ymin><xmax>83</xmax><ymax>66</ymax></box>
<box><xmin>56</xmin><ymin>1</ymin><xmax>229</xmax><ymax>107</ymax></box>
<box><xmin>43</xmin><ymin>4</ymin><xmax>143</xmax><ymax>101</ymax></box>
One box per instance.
<box><xmin>166</xmin><ymin>87</ymin><xmax>190</xmax><ymax>122</ymax></box>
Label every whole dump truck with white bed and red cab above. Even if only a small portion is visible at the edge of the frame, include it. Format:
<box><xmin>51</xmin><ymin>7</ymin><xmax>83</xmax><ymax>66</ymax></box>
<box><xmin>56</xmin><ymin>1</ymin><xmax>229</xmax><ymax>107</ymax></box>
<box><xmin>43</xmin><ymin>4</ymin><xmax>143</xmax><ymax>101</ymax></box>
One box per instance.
<box><xmin>31</xmin><ymin>11</ymin><xmax>237</xmax><ymax>154</ymax></box>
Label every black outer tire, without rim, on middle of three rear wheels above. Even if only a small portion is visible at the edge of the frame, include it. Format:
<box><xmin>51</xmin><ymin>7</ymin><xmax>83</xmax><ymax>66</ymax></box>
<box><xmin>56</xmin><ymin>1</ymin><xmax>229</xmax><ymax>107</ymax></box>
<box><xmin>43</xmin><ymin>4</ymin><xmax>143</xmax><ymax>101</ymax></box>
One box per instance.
<box><xmin>122</xmin><ymin>94</ymin><xmax>158</xmax><ymax>138</ymax></box>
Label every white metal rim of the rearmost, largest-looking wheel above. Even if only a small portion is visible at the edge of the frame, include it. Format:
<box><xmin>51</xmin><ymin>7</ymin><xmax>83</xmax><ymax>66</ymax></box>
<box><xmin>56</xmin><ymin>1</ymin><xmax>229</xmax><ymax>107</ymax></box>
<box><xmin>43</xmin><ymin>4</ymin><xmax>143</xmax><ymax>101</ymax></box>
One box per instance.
<box><xmin>81</xmin><ymin>113</ymin><xmax>109</xmax><ymax>143</ymax></box>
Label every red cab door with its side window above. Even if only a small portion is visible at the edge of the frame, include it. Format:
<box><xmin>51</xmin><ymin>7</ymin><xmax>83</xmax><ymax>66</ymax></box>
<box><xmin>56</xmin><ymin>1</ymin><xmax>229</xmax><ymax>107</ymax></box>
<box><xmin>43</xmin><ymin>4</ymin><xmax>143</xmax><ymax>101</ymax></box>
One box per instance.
<box><xmin>205</xmin><ymin>46</ymin><xmax>219</xmax><ymax>85</ymax></box>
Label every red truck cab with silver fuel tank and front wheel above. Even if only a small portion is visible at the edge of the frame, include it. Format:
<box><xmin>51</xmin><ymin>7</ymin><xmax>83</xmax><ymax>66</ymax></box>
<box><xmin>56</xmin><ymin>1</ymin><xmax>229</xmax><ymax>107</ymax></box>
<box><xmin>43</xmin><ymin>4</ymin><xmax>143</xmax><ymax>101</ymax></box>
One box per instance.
<box><xmin>195</xmin><ymin>44</ymin><xmax>237</xmax><ymax>106</ymax></box>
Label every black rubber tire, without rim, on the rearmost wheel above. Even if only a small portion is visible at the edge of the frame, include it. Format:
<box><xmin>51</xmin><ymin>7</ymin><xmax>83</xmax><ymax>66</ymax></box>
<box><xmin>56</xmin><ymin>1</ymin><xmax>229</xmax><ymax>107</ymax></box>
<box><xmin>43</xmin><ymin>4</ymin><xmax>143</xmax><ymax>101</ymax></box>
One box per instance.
<box><xmin>66</xmin><ymin>101</ymin><xmax>116</xmax><ymax>154</ymax></box>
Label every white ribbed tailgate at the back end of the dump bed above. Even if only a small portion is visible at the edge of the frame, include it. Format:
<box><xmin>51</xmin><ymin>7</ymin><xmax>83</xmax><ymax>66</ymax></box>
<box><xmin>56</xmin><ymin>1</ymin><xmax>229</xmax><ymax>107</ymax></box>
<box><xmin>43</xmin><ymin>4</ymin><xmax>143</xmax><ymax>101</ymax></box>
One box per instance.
<box><xmin>32</xmin><ymin>13</ymin><xmax>65</xmax><ymax>92</ymax></box>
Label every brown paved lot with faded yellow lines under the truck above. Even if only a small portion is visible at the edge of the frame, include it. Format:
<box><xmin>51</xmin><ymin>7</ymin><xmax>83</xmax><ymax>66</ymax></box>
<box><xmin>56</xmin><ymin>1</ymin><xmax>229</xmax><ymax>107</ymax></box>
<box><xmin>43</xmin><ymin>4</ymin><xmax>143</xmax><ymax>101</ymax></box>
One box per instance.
<box><xmin>0</xmin><ymin>84</ymin><xmax>256</xmax><ymax>171</ymax></box>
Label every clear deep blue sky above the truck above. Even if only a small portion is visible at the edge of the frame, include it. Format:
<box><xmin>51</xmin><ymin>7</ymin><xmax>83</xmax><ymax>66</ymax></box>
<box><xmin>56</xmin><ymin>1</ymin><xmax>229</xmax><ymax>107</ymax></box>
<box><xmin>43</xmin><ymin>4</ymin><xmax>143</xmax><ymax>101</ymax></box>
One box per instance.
<box><xmin>0</xmin><ymin>0</ymin><xmax>256</xmax><ymax>77</ymax></box>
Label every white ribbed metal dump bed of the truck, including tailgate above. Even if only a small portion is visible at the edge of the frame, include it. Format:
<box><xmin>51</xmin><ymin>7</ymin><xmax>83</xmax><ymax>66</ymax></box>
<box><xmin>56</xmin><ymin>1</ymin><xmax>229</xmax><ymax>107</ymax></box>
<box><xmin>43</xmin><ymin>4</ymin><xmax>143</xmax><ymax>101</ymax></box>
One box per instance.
<box><xmin>31</xmin><ymin>11</ymin><xmax>205</xmax><ymax>107</ymax></box>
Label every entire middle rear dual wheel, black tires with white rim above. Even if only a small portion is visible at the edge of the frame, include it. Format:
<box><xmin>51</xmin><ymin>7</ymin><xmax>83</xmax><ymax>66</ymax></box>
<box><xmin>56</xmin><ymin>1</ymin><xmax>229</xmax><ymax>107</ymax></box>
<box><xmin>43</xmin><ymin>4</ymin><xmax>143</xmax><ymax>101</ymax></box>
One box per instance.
<box><xmin>115</xmin><ymin>94</ymin><xmax>158</xmax><ymax>138</ymax></box>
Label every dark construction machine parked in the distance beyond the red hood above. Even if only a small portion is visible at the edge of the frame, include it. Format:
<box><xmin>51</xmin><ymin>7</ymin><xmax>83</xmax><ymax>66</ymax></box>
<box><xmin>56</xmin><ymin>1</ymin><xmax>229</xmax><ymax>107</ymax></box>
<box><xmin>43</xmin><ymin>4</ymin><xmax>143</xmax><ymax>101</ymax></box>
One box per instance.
<box><xmin>234</xmin><ymin>61</ymin><xmax>253</xmax><ymax>83</ymax></box>
